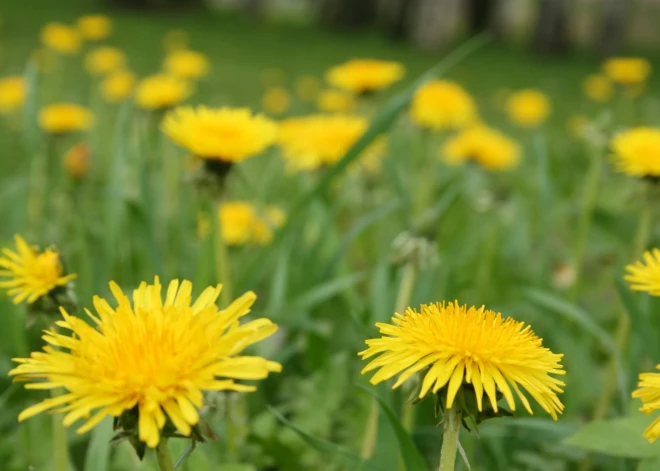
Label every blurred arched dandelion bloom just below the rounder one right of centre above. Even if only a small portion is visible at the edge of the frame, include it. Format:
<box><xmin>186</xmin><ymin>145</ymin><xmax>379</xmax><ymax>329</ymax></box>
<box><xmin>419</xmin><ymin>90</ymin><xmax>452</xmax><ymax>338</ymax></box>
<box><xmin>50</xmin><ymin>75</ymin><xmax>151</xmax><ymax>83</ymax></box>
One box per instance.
<box><xmin>442</xmin><ymin>125</ymin><xmax>520</xmax><ymax>170</ymax></box>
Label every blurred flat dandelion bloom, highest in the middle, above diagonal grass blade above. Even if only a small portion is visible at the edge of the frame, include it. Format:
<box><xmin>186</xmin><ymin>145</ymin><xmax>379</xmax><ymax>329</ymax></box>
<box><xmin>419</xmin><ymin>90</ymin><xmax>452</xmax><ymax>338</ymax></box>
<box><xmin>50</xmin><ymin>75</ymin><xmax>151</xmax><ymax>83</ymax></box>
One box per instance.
<box><xmin>326</xmin><ymin>59</ymin><xmax>406</xmax><ymax>94</ymax></box>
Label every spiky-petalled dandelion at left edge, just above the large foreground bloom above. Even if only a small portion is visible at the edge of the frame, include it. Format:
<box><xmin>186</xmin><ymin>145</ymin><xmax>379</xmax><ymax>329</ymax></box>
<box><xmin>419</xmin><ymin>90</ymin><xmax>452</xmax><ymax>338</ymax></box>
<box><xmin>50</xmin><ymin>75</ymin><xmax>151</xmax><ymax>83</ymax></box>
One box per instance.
<box><xmin>0</xmin><ymin>235</ymin><xmax>76</xmax><ymax>304</ymax></box>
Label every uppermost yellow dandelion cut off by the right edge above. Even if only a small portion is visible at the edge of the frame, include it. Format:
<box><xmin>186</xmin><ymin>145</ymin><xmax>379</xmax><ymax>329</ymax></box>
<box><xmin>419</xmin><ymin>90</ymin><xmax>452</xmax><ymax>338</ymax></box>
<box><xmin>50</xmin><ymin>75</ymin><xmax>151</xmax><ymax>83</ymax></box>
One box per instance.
<box><xmin>610</xmin><ymin>127</ymin><xmax>660</xmax><ymax>177</ymax></box>
